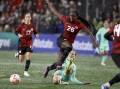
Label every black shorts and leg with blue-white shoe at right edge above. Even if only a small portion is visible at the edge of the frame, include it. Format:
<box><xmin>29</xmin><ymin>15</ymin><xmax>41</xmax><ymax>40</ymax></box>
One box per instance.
<box><xmin>101</xmin><ymin>54</ymin><xmax>120</xmax><ymax>89</ymax></box>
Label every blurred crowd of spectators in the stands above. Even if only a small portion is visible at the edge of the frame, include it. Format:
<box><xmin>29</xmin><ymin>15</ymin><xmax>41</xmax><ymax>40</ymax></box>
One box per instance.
<box><xmin>0</xmin><ymin>0</ymin><xmax>120</xmax><ymax>34</ymax></box>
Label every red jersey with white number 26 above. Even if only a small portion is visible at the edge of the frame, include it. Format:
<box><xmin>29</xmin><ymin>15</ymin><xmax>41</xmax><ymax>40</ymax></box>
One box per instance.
<box><xmin>59</xmin><ymin>16</ymin><xmax>87</xmax><ymax>43</ymax></box>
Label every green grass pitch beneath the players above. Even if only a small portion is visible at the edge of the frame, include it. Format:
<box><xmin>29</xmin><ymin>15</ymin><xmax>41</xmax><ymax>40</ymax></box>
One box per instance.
<box><xmin>0</xmin><ymin>51</ymin><xmax>120</xmax><ymax>89</ymax></box>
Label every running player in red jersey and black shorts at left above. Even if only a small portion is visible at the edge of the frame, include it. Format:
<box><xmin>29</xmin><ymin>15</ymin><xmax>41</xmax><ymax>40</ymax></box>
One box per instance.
<box><xmin>16</xmin><ymin>13</ymin><xmax>37</xmax><ymax>77</ymax></box>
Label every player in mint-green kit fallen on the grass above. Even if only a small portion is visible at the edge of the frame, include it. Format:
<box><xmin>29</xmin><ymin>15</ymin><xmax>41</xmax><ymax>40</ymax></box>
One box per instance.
<box><xmin>53</xmin><ymin>51</ymin><xmax>84</xmax><ymax>84</ymax></box>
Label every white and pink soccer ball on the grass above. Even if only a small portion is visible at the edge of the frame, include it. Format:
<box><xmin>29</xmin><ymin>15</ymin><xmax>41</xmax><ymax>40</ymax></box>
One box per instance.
<box><xmin>10</xmin><ymin>74</ymin><xmax>21</xmax><ymax>85</ymax></box>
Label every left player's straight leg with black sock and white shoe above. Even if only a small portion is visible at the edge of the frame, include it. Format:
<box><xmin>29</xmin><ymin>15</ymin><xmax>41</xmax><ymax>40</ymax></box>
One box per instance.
<box><xmin>24</xmin><ymin>47</ymin><xmax>32</xmax><ymax>77</ymax></box>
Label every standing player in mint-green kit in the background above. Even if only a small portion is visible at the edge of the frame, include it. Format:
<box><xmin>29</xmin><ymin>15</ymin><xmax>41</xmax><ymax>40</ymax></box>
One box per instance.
<box><xmin>96</xmin><ymin>20</ymin><xmax>109</xmax><ymax>66</ymax></box>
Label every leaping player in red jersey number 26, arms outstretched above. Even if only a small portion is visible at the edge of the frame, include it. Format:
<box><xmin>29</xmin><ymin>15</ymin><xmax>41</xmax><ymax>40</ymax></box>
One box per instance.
<box><xmin>44</xmin><ymin>0</ymin><xmax>96</xmax><ymax>77</ymax></box>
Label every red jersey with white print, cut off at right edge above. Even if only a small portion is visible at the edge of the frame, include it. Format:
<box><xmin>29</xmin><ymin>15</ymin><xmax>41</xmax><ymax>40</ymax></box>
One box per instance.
<box><xmin>108</xmin><ymin>24</ymin><xmax>120</xmax><ymax>54</ymax></box>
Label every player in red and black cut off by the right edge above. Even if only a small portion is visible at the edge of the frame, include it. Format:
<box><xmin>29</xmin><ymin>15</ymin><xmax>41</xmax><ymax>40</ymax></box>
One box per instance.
<box><xmin>101</xmin><ymin>21</ymin><xmax>120</xmax><ymax>89</ymax></box>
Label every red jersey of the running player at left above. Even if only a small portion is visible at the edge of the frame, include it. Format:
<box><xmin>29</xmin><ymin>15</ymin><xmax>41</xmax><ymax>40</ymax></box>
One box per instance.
<box><xmin>16</xmin><ymin>23</ymin><xmax>37</xmax><ymax>47</ymax></box>
